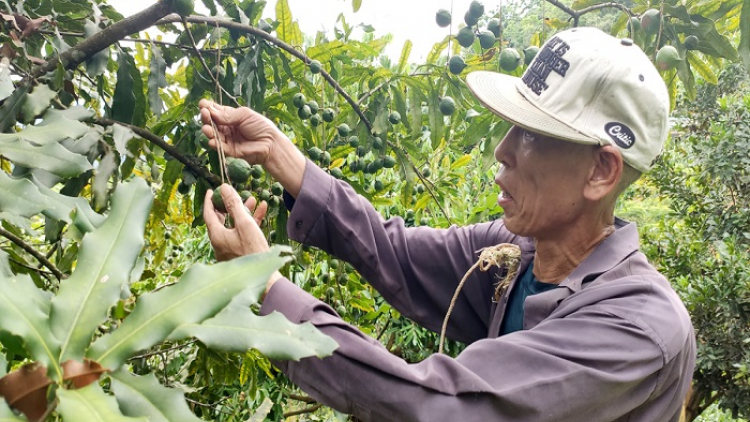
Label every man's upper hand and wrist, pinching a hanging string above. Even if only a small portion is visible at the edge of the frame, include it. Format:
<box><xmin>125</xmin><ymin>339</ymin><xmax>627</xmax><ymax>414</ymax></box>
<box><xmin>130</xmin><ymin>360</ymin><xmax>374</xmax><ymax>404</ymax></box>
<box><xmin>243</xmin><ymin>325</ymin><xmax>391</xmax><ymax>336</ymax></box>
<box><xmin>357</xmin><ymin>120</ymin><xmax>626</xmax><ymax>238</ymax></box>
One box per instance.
<box><xmin>198</xmin><ymin>99</ymin><xmax>306</xmax><ymax>198</ymax></box>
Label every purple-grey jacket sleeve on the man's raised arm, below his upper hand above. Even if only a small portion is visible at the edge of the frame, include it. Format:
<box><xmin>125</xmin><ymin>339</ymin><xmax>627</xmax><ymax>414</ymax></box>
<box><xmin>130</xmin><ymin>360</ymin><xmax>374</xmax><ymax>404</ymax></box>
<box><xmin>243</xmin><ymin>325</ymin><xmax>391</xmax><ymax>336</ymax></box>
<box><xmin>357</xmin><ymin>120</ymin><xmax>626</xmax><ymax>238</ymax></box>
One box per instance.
<box><xmin>287</xmin><ymin>161</ymin><xmax>515</xmax><ymax>343</ymax></box>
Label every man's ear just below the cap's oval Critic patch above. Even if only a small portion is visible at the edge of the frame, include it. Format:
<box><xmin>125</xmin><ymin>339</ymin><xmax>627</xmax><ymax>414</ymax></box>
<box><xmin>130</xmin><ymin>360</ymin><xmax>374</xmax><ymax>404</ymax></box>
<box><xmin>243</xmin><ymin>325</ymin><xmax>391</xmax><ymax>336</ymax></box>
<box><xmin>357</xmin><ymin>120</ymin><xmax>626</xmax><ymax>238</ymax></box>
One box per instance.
<box><xmin>583</xmin><ymin>145</ymin><xmax>624</xmax><ymax>201</ymax></box>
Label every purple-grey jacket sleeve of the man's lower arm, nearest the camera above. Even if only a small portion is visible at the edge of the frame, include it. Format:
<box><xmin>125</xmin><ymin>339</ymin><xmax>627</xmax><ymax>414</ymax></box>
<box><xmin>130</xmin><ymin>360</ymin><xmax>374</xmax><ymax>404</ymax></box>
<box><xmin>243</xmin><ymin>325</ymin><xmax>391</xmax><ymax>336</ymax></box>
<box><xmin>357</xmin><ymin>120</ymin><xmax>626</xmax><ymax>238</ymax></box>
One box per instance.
<box><xmin>261</xmin><ymin>279</ymin><xmax>668</xmax><ymax>422</ymax></box>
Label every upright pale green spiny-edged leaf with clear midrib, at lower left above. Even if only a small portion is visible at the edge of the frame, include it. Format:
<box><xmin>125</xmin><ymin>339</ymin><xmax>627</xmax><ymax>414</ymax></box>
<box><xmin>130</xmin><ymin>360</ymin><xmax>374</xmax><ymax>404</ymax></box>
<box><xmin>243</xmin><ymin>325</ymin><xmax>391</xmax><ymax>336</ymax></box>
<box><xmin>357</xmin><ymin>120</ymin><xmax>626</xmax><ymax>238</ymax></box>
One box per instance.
<box><xmin>50</xmin><ymin>179</ymin><xmax>153</xmax><ymax>362</ymax></box>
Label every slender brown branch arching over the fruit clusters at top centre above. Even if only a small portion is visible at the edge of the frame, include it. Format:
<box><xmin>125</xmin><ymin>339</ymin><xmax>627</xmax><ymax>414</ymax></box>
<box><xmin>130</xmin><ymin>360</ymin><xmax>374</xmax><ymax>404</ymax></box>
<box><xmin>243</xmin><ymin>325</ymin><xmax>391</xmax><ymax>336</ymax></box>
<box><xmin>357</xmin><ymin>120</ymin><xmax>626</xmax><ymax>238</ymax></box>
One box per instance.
<box><xmin>156</xmin><ymin>16</ymin><xmax>372</xmax><ymax>132</ymax></box>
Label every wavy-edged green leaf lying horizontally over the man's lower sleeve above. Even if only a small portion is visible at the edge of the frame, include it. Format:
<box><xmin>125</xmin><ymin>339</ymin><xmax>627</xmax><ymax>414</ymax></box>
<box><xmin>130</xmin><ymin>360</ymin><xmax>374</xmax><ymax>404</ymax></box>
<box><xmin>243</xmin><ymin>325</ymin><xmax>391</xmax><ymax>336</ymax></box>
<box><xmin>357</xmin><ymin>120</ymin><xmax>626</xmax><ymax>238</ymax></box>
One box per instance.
<box><xmin>169</xmin><ymin>305</ymin><xmax>338</xmax><ymax>360</ymax></box>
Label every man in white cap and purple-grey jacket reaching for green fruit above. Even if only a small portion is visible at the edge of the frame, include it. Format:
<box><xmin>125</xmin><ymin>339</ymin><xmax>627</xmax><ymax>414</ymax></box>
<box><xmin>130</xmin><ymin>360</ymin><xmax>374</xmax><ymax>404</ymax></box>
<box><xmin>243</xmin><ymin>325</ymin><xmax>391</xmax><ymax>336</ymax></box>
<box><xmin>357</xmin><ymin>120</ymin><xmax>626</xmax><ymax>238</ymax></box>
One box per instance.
<box><xmin>201</xmin><ymin>28</ymin><xmax>695</xmax><ymax>422</ymax></box>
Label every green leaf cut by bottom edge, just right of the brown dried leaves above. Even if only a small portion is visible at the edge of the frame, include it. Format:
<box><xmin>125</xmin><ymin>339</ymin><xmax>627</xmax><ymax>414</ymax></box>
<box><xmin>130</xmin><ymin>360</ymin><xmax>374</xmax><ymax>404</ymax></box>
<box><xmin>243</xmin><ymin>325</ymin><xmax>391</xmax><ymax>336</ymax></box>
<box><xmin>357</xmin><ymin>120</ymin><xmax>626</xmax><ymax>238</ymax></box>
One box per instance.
<box><xmin>109</xmin><ymin>369</ymin><xmax>201</xmax><ymax>422</ymax></box>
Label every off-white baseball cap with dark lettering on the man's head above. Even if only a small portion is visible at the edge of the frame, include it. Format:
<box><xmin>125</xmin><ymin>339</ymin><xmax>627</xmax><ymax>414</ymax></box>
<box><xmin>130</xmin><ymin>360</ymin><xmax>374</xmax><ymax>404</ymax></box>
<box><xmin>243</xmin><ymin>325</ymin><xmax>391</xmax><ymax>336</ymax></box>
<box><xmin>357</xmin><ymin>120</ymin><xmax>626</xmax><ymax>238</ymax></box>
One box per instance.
<box><xmin>466</xmin><ymin>28</ymin><xmax>669</xmax><ymax>172</ymax></box>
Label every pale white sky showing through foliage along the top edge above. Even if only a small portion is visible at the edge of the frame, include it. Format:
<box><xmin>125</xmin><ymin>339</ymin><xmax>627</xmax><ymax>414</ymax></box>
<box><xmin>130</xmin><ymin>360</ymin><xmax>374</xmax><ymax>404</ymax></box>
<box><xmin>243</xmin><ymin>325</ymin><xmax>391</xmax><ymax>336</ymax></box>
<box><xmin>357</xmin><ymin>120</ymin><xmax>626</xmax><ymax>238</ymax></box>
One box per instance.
<box><xmin>108</xmin><ymin>0</ymin><xmax>482</xmax><ymax>62</ymax></box>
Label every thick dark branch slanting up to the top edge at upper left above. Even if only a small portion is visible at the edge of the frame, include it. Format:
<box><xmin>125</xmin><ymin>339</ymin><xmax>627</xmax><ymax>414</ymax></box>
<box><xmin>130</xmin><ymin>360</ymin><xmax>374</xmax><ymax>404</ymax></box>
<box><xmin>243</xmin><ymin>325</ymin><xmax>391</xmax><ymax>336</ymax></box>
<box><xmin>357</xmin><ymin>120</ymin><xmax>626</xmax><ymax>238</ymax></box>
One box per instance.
<box><xmin>33</xmin><ymin>1</ymin><xmax>172</xmax><ymax>78</ymax></box>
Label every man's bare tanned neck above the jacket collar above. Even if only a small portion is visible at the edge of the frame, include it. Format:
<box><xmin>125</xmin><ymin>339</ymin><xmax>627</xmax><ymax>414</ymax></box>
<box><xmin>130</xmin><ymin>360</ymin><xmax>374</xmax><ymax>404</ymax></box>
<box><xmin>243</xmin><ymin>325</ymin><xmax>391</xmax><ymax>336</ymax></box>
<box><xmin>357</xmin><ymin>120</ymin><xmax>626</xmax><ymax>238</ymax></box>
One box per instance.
<box><xmin>534</xmin><ymin>223</ymin><xmax>615</xmax><ymax>284</ymax></box>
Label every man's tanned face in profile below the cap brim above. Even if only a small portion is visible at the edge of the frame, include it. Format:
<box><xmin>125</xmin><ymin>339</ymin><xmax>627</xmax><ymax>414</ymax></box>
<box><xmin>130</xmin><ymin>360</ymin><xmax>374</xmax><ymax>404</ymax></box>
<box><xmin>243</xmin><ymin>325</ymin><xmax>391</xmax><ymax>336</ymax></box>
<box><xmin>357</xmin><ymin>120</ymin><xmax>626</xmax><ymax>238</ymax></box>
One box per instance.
<box><xmin>495</xmin><ymin>126</ymin><xmax>596</xmax><ymax>240</ymax></box>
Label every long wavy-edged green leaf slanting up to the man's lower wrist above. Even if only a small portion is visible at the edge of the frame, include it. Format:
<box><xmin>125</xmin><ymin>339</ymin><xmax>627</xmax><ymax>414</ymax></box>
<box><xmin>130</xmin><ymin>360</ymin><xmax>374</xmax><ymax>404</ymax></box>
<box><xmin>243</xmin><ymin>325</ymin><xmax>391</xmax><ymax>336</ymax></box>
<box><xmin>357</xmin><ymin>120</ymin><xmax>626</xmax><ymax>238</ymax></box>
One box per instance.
<box><xmin>87</xmin><ymin>248</ymin><xmax>287</xmax><ymax>368</ymax></box>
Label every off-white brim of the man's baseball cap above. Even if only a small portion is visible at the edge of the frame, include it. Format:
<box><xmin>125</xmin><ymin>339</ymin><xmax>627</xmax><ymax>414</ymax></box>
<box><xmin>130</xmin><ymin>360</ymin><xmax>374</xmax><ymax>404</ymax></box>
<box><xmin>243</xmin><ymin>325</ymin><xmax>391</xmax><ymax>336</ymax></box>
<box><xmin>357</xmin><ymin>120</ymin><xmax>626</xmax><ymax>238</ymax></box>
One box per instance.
<box><xmin>466</xmin><ymin>71</ymin><xmax>600</xmax><ymax>144</ymax></box>
